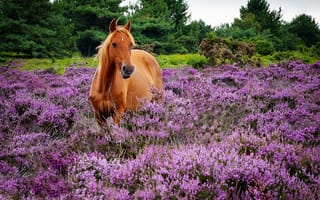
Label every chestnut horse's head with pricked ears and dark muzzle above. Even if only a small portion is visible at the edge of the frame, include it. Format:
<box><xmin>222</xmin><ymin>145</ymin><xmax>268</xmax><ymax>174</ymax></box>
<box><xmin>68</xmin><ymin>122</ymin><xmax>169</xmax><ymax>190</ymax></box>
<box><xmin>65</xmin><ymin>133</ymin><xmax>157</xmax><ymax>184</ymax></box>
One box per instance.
<box><xmin>108</xmin><ymin>19</ymin><xmax>134</xmax><ymax>79</ymax></box>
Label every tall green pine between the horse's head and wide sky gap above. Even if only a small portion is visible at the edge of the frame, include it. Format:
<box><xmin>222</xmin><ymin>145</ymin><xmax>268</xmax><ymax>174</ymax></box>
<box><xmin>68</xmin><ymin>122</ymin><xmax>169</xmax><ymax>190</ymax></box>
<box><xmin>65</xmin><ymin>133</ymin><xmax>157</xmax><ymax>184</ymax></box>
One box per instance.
<box><xmin>129</xmin><ymin>0</ymin><xmax>194</xmax><ymax>54</ymax></box>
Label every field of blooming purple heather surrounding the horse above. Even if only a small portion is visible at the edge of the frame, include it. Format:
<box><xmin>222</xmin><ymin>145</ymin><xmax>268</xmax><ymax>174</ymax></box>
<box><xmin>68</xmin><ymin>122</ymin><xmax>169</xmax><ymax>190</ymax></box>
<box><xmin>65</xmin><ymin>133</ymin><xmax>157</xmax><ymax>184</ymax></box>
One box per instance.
<box><xmin>0</xmin><ymin>60</ymin><xmax>320</xmax><ymax>199</ymax></box>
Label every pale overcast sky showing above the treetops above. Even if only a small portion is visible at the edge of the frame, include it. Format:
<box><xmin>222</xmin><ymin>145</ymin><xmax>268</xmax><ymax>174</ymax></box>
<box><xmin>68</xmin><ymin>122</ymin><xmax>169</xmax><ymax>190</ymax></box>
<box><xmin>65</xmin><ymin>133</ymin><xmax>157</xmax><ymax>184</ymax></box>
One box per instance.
<box><xmin>122</xmin><ymin>0</ymin><xmax>320</xmax><ymax>27</ymax></box>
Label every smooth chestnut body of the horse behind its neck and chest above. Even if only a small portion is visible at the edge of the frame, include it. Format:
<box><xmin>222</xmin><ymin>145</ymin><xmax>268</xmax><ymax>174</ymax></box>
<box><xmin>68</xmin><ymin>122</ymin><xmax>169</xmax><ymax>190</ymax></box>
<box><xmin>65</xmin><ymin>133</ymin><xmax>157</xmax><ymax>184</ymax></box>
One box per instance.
<box><xmin>127</xmin><ymin>50</ymin><xmax>162</xmax><ymax>108</ymax></box>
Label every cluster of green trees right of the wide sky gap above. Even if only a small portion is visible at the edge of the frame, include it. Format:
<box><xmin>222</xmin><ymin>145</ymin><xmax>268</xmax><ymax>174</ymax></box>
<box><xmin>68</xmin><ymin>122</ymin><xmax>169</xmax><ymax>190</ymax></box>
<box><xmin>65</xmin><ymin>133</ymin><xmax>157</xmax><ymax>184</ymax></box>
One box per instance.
<box><xmin>214</xmin><ymin>0</ymin><xmax>320</xmax><ymax>55</ymax></box>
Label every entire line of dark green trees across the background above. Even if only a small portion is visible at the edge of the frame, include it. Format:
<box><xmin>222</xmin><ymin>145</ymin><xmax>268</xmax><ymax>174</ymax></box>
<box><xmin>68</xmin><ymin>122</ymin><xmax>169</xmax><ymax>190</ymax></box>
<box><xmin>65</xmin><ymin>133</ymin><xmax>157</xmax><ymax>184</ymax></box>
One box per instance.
<box><xmin>0</xmin><ymin>0</ymin><xmax>320</xmax><ymax>58</ymax></box>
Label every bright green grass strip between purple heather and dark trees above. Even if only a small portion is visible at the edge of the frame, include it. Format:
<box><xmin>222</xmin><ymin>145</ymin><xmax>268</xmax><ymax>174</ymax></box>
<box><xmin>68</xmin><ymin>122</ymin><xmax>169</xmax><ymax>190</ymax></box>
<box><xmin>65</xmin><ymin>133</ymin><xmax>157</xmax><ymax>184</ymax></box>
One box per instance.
<box><xmin>0</xmin><ymin>51</ymin><xmax>319</xmax><ymax>74</ymax></box>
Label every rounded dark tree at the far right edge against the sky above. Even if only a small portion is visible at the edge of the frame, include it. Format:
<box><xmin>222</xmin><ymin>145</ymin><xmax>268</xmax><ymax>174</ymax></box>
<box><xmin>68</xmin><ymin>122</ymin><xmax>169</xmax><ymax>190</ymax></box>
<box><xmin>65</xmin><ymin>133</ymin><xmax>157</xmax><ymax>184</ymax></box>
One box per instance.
<box><xmin>288</xmin><ymin>14</ymin><xmax>320</xmax><ymax>47</ymax></box>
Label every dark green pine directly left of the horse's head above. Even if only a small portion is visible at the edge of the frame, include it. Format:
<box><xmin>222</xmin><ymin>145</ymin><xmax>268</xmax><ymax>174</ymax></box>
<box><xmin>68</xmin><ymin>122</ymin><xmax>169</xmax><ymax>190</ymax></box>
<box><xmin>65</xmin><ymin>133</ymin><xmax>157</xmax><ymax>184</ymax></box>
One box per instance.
<box><xmin>57</xmin><ymin>0</ymin><xmax>127</xmax><ymax>56</ymax></box>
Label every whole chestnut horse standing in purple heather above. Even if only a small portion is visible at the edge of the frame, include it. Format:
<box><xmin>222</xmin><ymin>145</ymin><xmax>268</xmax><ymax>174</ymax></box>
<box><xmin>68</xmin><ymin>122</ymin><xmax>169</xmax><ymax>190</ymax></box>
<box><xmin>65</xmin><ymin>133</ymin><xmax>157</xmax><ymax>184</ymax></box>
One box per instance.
<box><xmin>89</xmin><ymin>19</ymin><xmax>162</xmax><ymax>126</ymax></box>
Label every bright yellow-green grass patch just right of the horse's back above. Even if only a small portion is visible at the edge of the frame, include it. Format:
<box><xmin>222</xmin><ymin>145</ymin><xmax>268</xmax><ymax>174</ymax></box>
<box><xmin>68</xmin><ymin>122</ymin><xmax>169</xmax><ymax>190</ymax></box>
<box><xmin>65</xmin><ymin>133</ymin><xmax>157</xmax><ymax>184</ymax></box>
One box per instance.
<box><xmin>157</xmin><ymin>54</ymin><xmax>207</xmax><ymax>68</ymax></box>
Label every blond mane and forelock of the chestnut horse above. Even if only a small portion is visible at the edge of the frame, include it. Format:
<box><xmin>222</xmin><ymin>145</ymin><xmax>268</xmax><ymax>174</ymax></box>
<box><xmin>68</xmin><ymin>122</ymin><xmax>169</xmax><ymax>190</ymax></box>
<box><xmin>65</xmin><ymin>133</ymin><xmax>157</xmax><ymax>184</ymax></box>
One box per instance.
<box><xmin>96</xmin><ymin>26</ymin><xmax>135</xmax><ymax>92</ymax></box>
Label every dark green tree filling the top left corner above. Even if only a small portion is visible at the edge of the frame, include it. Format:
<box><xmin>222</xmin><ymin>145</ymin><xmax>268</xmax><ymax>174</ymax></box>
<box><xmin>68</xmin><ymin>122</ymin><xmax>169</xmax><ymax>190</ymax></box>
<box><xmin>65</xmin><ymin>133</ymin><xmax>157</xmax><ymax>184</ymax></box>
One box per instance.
<box><xmin>0</xmin><ymin>0</ymin><xmax>75</xmax><ymax>58</ymax></box>
